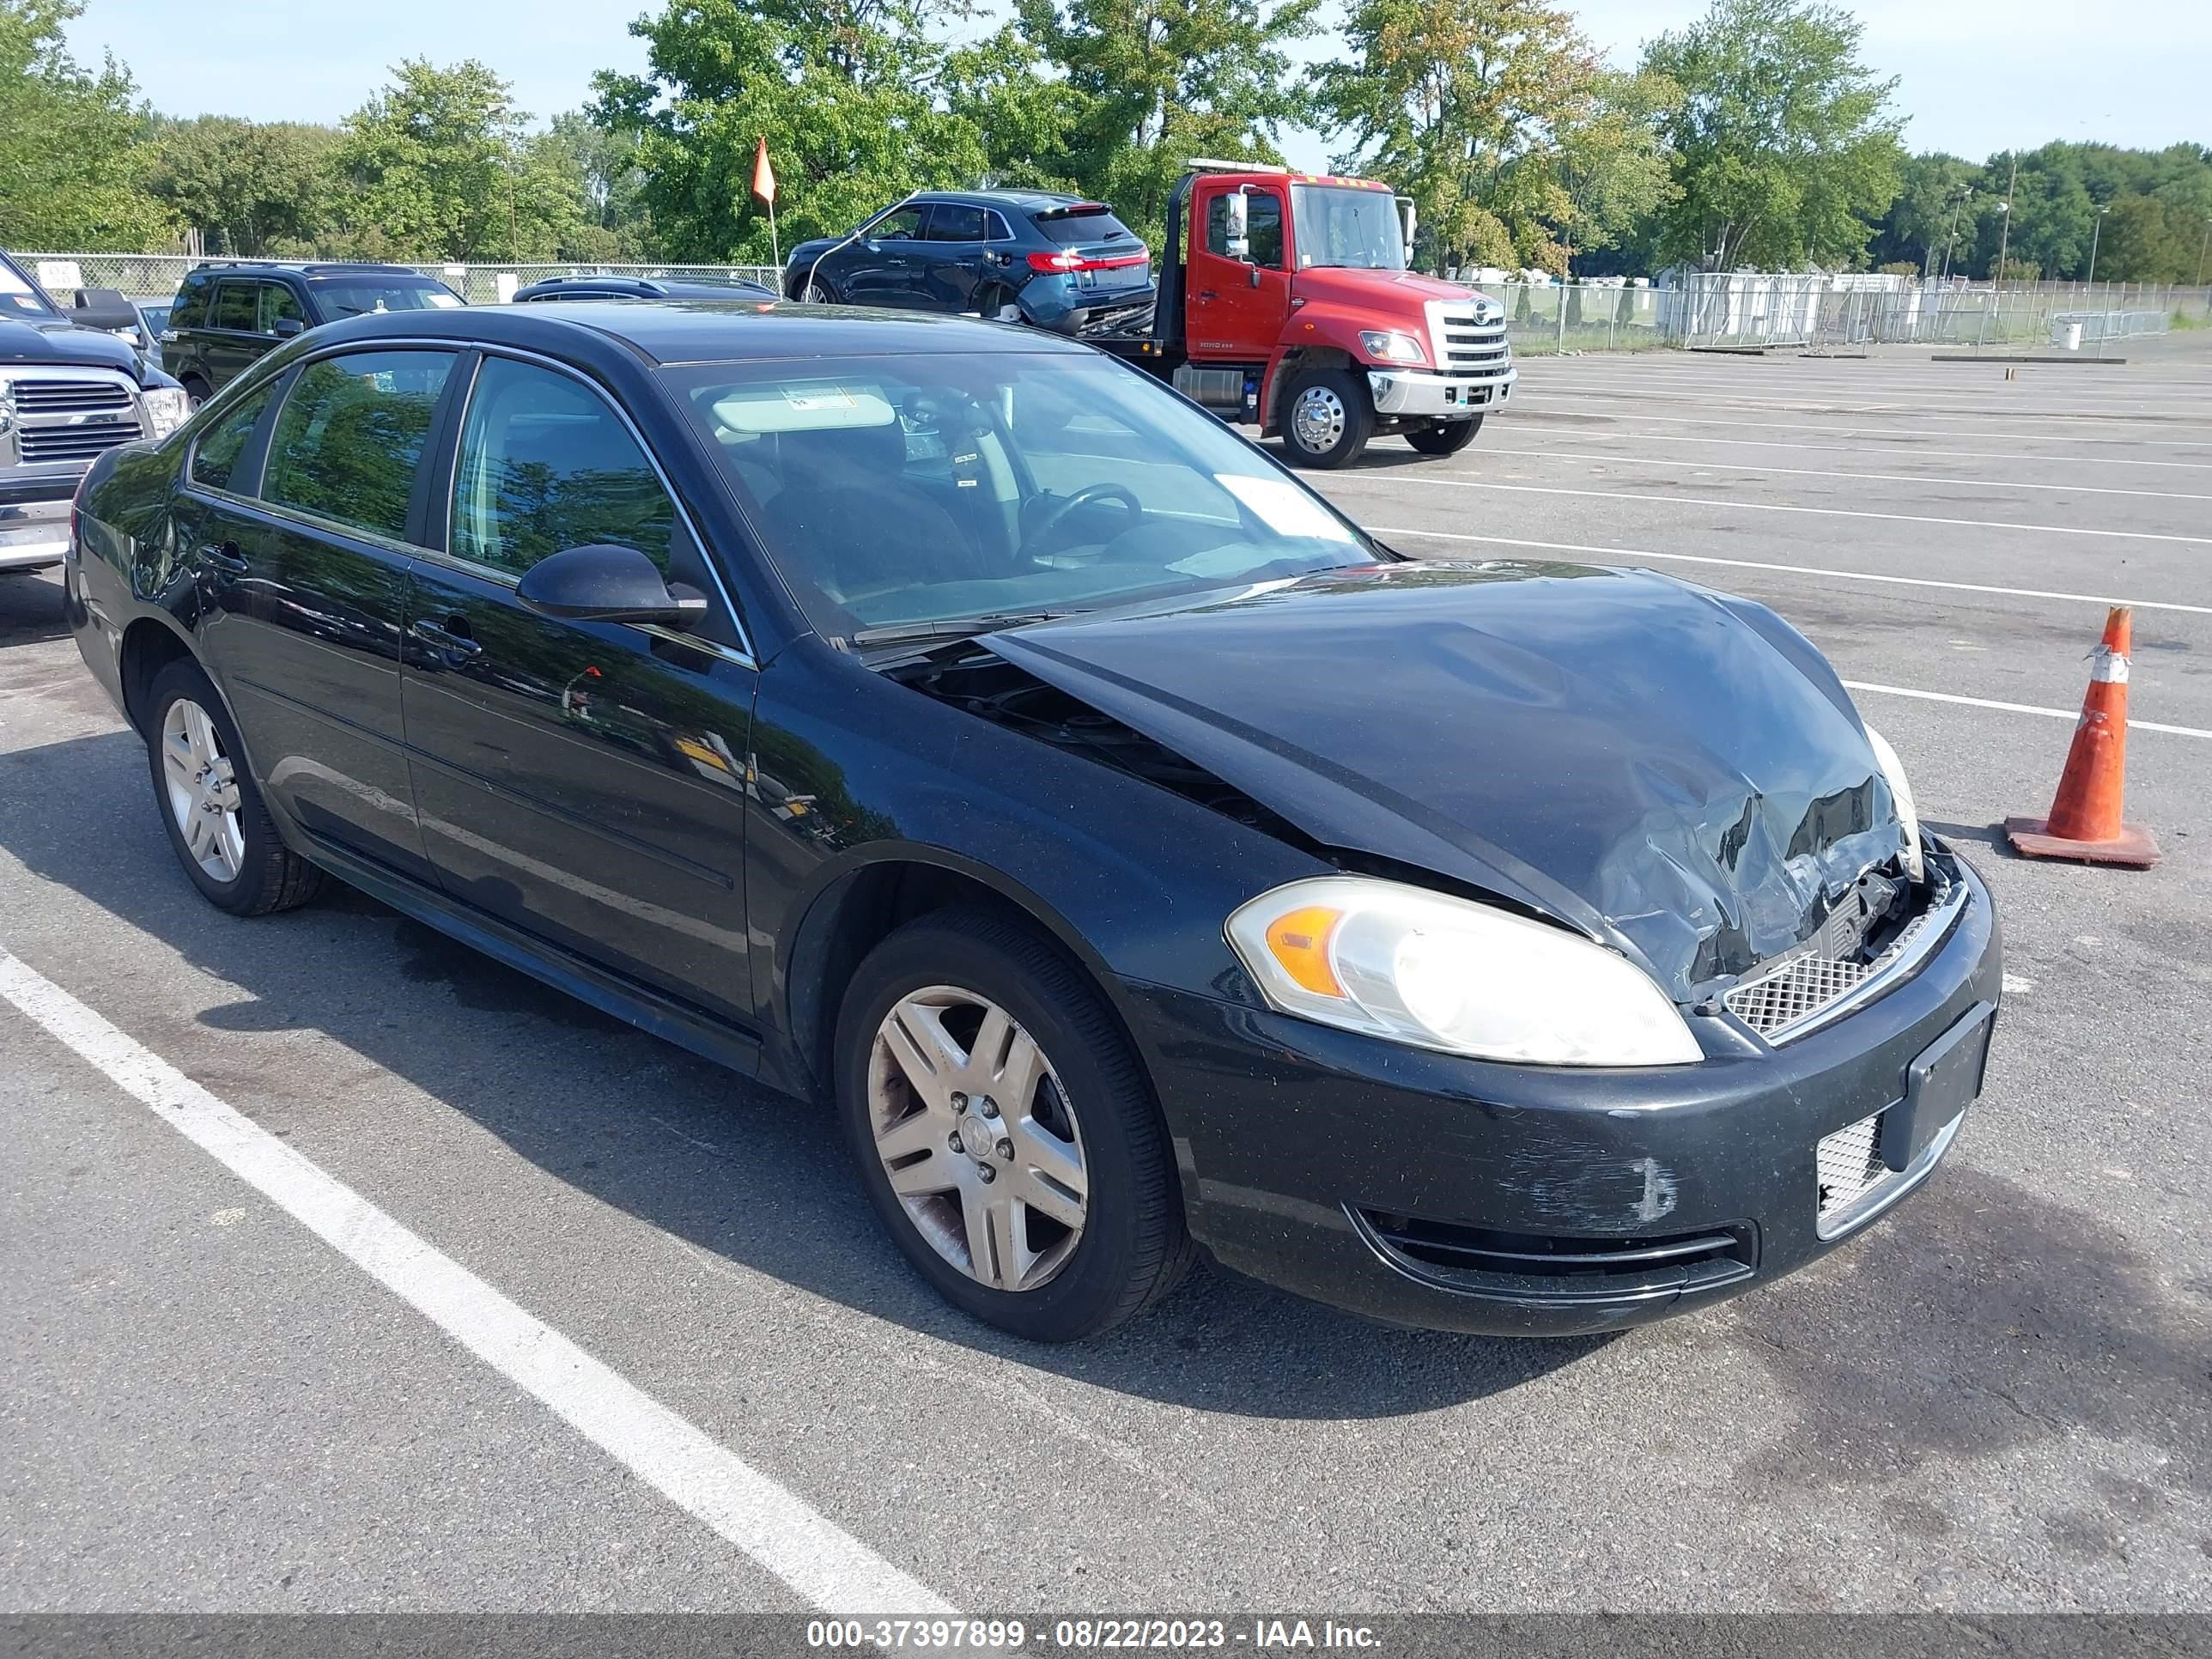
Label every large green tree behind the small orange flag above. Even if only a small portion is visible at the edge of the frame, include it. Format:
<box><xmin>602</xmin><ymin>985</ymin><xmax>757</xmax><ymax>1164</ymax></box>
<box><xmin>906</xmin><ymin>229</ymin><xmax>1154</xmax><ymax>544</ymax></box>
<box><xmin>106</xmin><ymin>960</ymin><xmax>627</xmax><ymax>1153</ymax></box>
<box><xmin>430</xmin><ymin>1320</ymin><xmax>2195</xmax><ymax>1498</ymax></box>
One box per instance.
<box><xmin>592</xmin><ymin>0</ymin><xmax>987</xmax><ymax>264</ymax></box>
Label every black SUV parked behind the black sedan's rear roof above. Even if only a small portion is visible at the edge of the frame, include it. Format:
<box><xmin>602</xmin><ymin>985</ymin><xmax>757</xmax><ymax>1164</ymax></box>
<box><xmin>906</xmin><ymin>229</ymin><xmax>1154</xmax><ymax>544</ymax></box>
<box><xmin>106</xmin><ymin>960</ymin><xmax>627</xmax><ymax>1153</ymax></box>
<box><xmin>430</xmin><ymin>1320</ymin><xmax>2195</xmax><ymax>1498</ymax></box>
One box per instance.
<box><xmin>161</xmin><ymin>264</ymin><xmax>462</xmax><ymax>403</ymax></box>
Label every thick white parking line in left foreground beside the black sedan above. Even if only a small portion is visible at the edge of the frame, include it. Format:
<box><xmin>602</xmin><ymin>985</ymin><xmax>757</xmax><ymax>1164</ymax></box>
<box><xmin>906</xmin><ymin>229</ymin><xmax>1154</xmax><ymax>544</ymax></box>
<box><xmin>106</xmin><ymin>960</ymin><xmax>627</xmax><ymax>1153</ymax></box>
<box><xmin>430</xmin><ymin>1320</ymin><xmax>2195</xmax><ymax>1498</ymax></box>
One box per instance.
<box><xmin>0</xmin><ymin>947</ymin><xmax>951</xmax><ymax>1614</ymax></box>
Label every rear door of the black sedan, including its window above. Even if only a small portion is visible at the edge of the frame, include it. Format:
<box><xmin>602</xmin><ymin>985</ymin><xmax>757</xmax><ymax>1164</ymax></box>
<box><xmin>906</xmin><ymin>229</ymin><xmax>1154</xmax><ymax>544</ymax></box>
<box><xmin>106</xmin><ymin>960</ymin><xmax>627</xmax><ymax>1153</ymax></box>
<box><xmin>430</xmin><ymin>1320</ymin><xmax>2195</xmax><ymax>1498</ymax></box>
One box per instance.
<box><xmin>179</xmin><ymin>347</ymin><xmax>458</xmax><ymax>880</ymax></box>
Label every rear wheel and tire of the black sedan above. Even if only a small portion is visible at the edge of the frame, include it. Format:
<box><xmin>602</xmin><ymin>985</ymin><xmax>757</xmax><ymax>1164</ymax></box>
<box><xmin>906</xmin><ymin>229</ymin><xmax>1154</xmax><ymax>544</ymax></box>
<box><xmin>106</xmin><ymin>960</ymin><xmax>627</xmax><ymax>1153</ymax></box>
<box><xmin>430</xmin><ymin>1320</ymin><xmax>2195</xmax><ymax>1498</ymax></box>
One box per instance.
<box><xmin>146</xmin><ymin>659</ymin><xmax>323</xmax><ymax>915</ymax></box>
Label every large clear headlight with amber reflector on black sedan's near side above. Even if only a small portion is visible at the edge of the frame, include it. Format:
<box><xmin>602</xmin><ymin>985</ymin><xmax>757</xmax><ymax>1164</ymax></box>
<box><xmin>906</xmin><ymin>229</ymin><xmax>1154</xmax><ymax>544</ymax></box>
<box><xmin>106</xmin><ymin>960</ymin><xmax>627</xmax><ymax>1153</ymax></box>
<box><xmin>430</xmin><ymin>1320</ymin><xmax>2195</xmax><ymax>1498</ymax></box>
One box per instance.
<box><xmin>1228</xmin><ymin>876</ymin><xmax>1704</xmax><ymax>1066</ymax></box>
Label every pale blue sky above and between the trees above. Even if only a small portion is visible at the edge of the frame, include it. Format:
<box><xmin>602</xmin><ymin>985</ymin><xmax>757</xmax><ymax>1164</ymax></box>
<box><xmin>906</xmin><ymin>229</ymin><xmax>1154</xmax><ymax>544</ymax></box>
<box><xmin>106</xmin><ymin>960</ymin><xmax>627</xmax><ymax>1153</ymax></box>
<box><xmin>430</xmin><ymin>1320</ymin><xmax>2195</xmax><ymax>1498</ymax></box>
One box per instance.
<box><xmin>69</xmin><ymin>0</ymin><xmax>2212</xmax><ymax>168</ymax></box>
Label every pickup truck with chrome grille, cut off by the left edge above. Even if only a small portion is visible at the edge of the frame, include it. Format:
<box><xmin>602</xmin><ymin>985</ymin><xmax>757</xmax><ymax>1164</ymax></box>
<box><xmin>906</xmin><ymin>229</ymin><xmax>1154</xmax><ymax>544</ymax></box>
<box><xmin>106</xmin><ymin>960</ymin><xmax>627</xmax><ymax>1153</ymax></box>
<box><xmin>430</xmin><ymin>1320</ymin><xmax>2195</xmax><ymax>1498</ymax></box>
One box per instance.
<box><xmin>0</xmin><ymin>254</ymin><xmax>191</xmax><ymax>575</ymax></box>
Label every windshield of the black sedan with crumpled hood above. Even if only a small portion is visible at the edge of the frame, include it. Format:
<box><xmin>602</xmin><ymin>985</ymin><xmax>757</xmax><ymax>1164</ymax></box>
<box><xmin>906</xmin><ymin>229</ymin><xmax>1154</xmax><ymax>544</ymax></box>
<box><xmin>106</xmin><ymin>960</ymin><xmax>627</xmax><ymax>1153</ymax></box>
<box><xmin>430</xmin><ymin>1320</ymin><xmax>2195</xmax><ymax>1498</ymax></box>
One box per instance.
<box><xmin>664</xmin><ymin>352</ymin><xmax>1385</xmax><ymax>635</ymax></box>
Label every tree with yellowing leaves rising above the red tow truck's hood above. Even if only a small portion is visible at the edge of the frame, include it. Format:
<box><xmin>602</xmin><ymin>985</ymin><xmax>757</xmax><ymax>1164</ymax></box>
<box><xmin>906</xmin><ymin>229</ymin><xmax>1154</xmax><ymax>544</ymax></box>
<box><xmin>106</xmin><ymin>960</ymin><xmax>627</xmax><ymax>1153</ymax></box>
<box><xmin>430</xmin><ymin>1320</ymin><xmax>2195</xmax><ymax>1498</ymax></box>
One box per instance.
<box><xmin>1314</xmin><ymin>0</ymin><xmax>1670</xmax><ymax>272</ymax></box>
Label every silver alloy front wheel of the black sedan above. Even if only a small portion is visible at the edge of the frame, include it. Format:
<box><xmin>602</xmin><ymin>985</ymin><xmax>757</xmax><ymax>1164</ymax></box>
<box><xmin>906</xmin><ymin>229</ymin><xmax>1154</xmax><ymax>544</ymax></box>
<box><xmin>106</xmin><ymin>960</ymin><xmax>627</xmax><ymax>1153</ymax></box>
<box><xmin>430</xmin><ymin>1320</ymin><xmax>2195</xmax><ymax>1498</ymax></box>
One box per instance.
<box><xmin>867</xmin><ymin>984</ymin><xmax>1091</xmax><ymax>1291</ymax></box>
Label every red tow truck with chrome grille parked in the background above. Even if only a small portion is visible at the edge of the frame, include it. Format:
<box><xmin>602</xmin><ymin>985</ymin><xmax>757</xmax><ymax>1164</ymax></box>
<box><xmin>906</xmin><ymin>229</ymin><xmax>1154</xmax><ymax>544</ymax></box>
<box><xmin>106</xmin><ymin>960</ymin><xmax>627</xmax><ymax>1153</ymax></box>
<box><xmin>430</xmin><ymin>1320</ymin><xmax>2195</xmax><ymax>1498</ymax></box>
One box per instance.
<box><xmin>1084</xmin><ymin>161</ymin><xmax>1516</xmax><ymax>467</ymax></box>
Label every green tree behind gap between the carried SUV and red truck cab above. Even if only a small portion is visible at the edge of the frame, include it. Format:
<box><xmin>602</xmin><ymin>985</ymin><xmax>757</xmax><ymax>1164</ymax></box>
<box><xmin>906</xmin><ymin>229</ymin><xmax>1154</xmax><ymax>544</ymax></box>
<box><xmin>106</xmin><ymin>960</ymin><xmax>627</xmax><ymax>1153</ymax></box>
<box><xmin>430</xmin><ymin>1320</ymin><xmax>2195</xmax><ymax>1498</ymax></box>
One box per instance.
<box><xmin>1015</xmin><ymin>0</ymin><xmax>1318</xmax><ymax>248</ymax></box>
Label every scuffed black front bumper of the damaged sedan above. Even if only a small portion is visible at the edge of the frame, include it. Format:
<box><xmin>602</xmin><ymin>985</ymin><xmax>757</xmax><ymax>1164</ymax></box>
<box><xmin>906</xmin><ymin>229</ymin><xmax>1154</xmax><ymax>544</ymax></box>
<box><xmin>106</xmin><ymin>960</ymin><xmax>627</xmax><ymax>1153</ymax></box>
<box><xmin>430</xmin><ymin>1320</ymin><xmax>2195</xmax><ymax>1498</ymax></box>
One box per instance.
<box><xmin>1126</xmin><ymin>863</ymin><xmax>2002</xmax><ymax>1336</ymax></box>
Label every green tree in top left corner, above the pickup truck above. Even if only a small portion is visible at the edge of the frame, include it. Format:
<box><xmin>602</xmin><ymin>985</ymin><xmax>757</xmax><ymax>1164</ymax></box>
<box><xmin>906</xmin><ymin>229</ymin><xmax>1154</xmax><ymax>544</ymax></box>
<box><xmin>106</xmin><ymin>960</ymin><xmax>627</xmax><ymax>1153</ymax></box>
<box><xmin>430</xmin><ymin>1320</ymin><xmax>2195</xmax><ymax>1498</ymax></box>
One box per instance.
<box><xmin>0</xmin><ymin>0</ymin><xmax>173</xmax><ymax>248</ymax></box>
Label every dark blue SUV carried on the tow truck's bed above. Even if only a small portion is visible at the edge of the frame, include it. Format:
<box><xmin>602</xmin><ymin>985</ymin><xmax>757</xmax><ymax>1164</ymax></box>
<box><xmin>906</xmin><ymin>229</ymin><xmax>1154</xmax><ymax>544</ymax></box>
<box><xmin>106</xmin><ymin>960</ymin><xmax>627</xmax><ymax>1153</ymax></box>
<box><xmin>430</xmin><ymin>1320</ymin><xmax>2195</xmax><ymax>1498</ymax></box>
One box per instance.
<box><xmin>783</xmin><ymin>191</ymin><xmax>1152</xmax><ymax>334</ymax></box>
